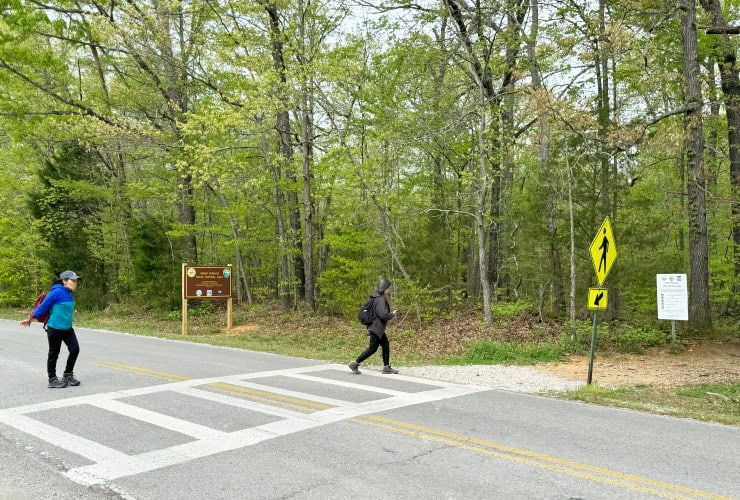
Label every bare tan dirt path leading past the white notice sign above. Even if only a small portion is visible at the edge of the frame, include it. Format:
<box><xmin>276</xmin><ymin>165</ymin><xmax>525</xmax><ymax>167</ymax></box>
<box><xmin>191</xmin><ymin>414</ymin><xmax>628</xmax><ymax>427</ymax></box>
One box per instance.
<box><xmin>536</xmin><ymin>339</ymin><xmax>740</xmax><ymax>387</ymax></box>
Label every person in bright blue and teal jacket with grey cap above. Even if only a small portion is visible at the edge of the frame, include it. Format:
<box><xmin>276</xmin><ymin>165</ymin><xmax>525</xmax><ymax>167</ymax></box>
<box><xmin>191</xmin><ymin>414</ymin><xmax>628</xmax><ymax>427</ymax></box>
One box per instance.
<box><xmin>21</xmin><ymin>271</ymin><xmax>80</xmax><ymax>389</ymax></box>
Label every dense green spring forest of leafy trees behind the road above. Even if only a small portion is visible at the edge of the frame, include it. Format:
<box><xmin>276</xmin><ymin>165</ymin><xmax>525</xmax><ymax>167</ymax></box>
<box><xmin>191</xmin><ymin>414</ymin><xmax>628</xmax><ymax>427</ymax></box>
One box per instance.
<box><xmin>0</xmin><ymin>0</ymin><xmax>740</xmax><ymax>327</ymax></box>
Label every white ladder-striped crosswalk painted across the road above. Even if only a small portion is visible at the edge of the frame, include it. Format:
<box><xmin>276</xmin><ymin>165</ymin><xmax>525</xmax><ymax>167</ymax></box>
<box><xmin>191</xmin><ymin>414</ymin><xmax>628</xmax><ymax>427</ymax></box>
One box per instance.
<box><xmin>0</xmin><ymin>365</ymin><xmax>486</xmax><ymax>486</ymax></box>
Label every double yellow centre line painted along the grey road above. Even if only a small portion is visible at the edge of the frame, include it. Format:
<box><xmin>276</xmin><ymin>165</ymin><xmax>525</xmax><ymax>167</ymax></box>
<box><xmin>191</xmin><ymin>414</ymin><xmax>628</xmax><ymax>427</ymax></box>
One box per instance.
<box><xmin>94</xmin><ymin>361</ymin><xmax>732</xmax><ymax>500</ymax></box>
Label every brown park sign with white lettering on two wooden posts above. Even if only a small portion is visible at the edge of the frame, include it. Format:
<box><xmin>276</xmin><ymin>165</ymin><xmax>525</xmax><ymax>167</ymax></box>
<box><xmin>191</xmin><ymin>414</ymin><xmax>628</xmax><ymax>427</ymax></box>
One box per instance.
<box><xmin>182</xmin><ymin>263</ymin><xmax>233</xmax><ymax>335</ymax></box>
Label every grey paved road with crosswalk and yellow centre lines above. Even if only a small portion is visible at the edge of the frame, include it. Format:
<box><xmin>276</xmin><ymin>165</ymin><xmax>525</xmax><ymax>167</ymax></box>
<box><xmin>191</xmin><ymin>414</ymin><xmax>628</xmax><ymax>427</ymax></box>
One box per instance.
<box><xmin>0</xmin><ymin>320</ymin><xmax>740</xmax><ymax>500</ymax></box>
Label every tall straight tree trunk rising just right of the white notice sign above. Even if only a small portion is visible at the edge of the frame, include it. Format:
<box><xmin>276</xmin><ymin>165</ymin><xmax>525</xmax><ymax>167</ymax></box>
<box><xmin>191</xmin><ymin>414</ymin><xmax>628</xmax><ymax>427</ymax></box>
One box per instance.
<box><xmin>680</xmin><ymin>0</ymin><xmax>712</xmax><ymax>329</ymax></box>
